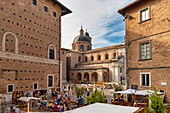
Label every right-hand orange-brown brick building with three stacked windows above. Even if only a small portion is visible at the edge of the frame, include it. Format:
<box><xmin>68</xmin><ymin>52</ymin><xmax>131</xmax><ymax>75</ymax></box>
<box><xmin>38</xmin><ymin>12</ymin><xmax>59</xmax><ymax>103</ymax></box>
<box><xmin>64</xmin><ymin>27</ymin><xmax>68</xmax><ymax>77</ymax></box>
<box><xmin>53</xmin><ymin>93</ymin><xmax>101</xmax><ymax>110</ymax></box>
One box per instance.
<box><xmin>118</xmin><ymin>0</ymin><xmax>170</xmax><ymax>102</ymax></box>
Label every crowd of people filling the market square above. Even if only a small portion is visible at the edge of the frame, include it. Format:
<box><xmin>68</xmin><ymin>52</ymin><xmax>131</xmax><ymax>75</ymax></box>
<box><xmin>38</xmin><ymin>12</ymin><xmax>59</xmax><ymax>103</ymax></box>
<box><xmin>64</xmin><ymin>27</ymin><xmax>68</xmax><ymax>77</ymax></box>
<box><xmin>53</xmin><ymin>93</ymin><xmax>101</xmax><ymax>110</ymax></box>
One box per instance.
<box><xmin>12</xmin><ymin>83</ymin><xmax>111</xmax><ymax>113</ymax></box>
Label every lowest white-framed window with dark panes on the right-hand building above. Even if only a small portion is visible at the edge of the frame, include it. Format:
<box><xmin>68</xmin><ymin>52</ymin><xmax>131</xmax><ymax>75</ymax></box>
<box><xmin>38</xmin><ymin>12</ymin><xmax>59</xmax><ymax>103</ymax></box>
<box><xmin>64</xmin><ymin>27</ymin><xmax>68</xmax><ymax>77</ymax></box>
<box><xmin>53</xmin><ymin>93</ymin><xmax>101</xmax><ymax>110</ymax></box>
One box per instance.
<box><xmin>140</xmin><ymin>73</ymin><xmax>151</xmax><ymax>86</ymax></box>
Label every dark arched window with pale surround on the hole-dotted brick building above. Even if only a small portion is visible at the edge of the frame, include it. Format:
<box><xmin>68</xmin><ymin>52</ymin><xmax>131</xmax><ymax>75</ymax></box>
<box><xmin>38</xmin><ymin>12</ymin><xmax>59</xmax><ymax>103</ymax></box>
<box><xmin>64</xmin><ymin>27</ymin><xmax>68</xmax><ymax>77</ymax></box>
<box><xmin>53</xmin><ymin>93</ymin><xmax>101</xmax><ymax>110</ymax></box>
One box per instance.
<box><xmin>48</xmin><ymin>44</ymin><xmax>56</xmax><ymax>59</ymax></box>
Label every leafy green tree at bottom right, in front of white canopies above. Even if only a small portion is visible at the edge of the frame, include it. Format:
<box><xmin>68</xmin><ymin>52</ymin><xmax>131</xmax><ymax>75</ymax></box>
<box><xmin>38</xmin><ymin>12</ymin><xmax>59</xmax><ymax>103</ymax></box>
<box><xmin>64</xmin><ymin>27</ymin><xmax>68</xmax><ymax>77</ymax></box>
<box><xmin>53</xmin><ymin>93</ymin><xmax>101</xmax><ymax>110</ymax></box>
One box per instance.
<box><xmin>146</xmin><ymin>87</ymin><xmax>165</xmax><ymax>113</ymax></box>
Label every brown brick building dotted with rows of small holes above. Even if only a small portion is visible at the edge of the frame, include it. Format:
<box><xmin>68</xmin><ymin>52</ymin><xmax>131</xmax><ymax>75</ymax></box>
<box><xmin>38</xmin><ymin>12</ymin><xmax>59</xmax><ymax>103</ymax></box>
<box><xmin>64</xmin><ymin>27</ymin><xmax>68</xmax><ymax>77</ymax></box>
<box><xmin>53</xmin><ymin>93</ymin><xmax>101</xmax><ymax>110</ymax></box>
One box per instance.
<box><xmin>0</xmin><ymin>0</ymin><xmax>71</xmax><ymax>101</ymax></box>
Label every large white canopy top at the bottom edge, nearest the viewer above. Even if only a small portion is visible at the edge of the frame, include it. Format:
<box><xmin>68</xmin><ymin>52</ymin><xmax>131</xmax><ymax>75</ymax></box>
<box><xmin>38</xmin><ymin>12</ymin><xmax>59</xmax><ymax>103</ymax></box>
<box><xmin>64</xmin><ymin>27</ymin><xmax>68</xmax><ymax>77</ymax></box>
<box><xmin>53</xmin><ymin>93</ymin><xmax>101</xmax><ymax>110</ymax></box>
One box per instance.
<box><xmin>69</xmin><ymin>103</ymin><xmax>139</xmax><ymax>113</ymax></box>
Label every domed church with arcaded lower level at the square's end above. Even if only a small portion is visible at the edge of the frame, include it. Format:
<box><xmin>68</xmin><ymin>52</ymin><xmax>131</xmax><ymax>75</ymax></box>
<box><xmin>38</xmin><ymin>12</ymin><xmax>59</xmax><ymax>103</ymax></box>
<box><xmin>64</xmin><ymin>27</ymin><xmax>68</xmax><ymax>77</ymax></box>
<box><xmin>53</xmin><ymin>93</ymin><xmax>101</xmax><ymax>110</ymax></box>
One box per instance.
<box><xmin>61</xmin><ymin>28</ymin><xmax>126</xmax><ymax>84</ymax></box>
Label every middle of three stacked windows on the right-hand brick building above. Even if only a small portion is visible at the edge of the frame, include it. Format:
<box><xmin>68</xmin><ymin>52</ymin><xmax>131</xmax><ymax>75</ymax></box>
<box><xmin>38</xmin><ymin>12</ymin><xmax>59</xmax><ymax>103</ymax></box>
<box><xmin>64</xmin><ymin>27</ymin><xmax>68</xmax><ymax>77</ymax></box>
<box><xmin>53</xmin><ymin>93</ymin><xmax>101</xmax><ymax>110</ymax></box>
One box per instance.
<box><xmin>140</xmin><ymin>42</ymin><xmax>151</xmax><ymax>60</ymax></box>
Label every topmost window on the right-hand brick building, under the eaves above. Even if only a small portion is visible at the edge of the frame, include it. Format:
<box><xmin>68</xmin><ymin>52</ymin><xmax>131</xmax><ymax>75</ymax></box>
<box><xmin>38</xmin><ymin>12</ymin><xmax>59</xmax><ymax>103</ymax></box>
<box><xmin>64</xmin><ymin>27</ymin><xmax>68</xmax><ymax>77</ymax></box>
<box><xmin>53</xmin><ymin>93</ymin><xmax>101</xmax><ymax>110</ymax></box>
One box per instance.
<box><xmin>140</xmin><ymin>8</ymin><xmax>149</xmax><ymax>22</ymax></box>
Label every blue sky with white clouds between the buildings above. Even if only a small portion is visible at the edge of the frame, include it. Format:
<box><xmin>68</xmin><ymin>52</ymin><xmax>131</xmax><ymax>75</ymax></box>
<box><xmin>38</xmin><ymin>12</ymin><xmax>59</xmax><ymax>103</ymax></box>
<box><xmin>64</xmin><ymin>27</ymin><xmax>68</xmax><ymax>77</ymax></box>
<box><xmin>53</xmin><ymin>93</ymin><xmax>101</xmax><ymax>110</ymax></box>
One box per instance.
<box><xmin>59</xmin><ymin>0</ymin><xmax>135</xmax><ymax>49</ymax></box>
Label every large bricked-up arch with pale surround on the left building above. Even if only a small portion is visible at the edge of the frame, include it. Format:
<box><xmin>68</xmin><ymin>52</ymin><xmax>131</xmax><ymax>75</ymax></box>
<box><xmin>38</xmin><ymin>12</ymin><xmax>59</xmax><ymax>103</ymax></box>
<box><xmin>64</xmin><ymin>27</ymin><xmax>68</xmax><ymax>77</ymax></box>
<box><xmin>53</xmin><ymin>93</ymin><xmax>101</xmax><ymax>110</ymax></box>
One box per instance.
<box><xmin>2</xmin><ymin>32</ymin><xmax>18</xmax><ymax>53</ymax></box>
